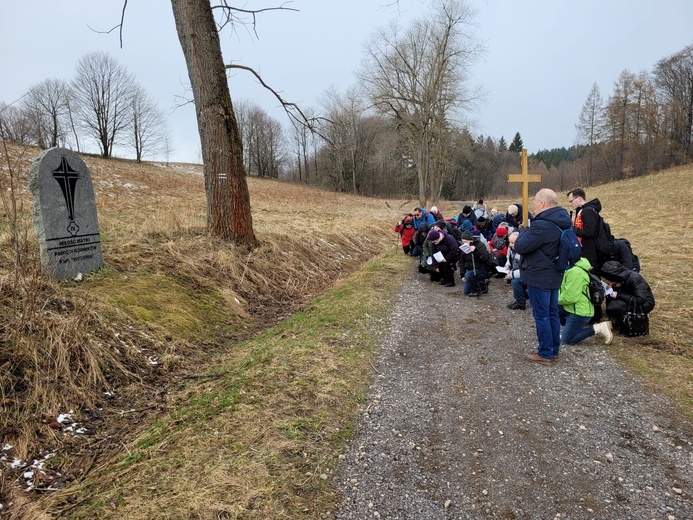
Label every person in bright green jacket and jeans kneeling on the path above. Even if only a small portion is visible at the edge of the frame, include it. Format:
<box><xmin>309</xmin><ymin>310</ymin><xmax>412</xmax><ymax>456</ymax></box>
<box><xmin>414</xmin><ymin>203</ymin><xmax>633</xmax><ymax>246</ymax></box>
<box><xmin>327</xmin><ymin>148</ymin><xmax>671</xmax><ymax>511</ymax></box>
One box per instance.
<box><xmin>553</xmin><ymin>257</ymin><xmax>613</xmax><ymax>346</ymax></box>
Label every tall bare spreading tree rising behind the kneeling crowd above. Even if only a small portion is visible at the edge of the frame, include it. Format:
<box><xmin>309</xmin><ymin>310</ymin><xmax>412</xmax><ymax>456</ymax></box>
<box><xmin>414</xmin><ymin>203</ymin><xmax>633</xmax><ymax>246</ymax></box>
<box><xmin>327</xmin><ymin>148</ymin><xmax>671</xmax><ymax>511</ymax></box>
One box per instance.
<box><xmin>359</xmin><ymin>0</ymin><xmax>482</xmax><ymax>204</ymax></box>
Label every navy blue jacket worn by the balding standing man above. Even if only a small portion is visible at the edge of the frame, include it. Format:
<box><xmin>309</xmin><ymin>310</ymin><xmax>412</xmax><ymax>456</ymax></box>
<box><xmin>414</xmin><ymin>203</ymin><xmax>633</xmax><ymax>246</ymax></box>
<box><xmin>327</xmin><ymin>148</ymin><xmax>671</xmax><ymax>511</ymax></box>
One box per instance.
<box><xmin>515</xmin><ymin>206</ymin><xmax>573</xmax><ymax>289</ymax></box>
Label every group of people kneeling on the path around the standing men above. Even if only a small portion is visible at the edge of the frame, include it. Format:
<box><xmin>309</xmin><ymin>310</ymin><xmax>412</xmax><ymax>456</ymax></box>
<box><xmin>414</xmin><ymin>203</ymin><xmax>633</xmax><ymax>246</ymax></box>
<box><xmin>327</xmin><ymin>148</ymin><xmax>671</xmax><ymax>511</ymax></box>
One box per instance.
<box><xmin>395</xmin><ymin>207</ymin><xmax>655</xmax><ymax>345</ymax></box>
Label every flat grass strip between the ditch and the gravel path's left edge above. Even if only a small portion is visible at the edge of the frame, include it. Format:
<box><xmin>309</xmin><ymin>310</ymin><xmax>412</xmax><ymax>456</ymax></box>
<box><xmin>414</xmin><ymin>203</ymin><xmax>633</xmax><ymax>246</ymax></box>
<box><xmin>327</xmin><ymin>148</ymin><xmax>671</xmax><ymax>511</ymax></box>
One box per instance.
<box><xmin>48</xmin><ymin>251</ymin><xmax>410</xmax><ymax>519</ymax></box>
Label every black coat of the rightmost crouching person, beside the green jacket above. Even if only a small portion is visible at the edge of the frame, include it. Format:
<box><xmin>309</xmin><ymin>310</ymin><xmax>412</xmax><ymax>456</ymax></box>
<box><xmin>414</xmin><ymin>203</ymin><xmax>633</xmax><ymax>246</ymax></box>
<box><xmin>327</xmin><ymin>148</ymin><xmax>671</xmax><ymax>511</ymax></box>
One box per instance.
<box><xmin>600</xmin><ymin>260</ymin><xmax>655</xmax><ymax>317</ymax></box>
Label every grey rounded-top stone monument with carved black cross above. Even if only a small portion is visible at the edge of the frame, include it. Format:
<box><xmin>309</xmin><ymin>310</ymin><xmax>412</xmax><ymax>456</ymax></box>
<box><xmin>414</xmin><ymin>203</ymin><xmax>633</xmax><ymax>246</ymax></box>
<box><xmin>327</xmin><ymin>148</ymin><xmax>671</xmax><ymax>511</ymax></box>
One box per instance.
<box><xmin>29</xmin><ymin>148</ymin><xmax>103</xmax><ymax>280</ymax></box>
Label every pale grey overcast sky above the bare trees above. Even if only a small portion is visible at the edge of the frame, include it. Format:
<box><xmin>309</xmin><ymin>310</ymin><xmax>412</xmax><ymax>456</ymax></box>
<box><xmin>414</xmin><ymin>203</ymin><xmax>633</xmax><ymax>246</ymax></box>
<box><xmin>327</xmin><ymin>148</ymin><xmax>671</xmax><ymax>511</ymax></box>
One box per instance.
<box><xmin>0</xmin><ymin>0</ymin><xmax>693</xmax><ymax>162</ymax></box>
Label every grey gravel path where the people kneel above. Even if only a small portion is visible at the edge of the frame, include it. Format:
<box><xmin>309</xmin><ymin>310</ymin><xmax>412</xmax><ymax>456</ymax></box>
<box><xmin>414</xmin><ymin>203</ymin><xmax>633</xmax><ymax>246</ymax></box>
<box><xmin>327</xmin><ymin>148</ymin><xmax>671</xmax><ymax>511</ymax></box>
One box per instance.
<box><xmin>335</xmin><ymin>266</ymin><xmax>693</xmax><ymax>520</ymax></box>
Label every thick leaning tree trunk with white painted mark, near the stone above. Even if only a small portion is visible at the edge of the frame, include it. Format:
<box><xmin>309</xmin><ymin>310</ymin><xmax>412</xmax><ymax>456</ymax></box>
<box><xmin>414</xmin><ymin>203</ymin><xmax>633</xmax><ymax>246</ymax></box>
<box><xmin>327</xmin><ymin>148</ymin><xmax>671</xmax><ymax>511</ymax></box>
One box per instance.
<box><xmin>171</xmin><ymin>0</ymin><xmax>256</xmax><ymax>246</ymax></box>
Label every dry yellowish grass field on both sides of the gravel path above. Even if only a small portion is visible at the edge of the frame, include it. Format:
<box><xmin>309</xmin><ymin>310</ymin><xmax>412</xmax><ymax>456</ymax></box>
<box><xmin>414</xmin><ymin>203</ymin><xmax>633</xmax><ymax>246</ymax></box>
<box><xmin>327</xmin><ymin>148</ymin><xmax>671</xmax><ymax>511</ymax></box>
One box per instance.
<box><xmin>0</xmin><ymin>140</ymin><xmax>693</xmax><ymax>519</ymax></box>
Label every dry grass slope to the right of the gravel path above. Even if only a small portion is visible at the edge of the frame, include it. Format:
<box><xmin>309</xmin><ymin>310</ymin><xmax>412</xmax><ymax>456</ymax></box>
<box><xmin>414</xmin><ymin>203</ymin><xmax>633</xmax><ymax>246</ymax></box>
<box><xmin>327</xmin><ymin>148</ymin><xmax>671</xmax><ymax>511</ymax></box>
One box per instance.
<box><xmin>587</xmin><ymin>165</ymin><xmax>693</xmax><ymax>419</ymax></box>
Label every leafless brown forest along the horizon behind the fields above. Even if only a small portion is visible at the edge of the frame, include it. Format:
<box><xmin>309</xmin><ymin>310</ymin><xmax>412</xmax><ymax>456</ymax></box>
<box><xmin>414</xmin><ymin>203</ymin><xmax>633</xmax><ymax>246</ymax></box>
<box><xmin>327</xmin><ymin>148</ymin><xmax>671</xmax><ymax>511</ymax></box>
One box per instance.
<box><xmin>0</xmin><ymin>21</ymin><xmax>693</xmax><ymax>201</ymax></box>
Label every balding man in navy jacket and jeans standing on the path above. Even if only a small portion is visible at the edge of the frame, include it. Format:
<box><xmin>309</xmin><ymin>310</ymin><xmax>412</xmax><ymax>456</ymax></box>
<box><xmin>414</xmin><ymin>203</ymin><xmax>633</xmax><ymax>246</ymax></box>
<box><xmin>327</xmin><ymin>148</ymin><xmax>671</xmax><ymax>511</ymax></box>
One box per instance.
<box><xmin>515</xmin><ymin>188</ymin><xmax>572</xmax><ymax>365</ymax></box>
